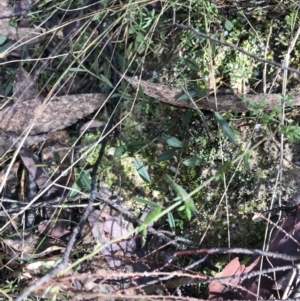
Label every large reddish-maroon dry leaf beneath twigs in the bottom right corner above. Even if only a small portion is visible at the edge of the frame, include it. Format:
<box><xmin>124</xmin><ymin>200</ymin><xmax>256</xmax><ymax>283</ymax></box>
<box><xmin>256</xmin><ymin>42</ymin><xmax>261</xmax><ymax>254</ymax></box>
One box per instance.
<box><xmin>208</xmin><ymin>206</ymin><xmax>300</xmax><ymax>301</ymax></box>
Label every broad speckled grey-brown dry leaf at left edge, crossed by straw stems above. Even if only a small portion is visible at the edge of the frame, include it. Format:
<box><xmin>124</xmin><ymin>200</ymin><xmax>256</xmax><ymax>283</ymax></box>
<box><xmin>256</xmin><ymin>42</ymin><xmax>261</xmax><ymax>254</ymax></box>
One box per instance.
<box><xmin>0</xmin><ymin>94</ymin><xmax>107</xmax><ymax>155</ymax></box>
